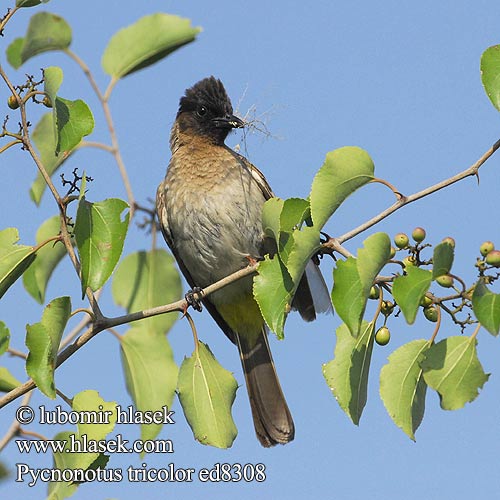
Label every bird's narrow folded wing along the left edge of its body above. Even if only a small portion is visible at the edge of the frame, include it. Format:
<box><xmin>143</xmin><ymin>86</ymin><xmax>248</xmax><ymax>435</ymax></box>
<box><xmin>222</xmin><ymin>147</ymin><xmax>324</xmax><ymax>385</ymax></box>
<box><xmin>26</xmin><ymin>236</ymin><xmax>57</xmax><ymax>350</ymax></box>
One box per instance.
<box><xmin>156</xmin><ymin>181</ymin><xmax>236</xmax><ymax>344</ymax></box>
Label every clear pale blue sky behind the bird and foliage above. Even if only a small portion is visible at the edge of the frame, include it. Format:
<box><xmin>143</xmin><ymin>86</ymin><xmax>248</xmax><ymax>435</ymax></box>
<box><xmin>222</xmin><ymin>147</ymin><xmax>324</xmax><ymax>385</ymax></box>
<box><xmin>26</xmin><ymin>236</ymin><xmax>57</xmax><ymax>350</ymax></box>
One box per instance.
<box><xmin>0</xmin><ymin>0</ymin><xmax>500</xmax><ymax>500</ymax></box>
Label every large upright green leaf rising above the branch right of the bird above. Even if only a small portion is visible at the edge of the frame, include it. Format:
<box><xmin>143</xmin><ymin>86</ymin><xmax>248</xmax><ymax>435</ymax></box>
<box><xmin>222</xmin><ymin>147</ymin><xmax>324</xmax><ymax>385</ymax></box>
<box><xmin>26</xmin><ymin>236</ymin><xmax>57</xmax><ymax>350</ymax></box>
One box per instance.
<box><xmin>309</xmin><ymin>146</ymin><xmax>374</xmax><ymax>230</ymax></box>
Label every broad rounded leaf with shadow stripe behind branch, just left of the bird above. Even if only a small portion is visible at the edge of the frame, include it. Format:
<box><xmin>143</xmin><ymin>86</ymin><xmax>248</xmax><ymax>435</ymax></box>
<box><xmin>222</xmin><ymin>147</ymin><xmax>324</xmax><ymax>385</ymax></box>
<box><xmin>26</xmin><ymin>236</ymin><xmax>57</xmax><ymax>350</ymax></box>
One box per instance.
<box><xmin>111</xmin><ymin>249</ymin><xmax>182</xmax><ymax>335</ymax></box>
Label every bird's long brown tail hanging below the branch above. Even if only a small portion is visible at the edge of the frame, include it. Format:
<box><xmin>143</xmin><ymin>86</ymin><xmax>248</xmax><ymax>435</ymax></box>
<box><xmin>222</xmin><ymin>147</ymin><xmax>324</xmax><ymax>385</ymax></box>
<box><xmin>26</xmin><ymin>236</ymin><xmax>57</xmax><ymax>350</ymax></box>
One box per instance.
<box><xmin>236</xmin><ymin>328</ymin><xmax>295</xmax><ymax>447</ymax></box>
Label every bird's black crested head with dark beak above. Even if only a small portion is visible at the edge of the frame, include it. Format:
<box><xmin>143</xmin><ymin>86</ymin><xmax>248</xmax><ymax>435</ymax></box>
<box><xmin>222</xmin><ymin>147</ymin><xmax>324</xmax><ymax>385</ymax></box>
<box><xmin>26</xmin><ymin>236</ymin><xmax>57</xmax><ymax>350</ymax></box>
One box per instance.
<box><xmin>177</xmin><ymin>76</ymin><xmax>244</xmax><ymax>144</ymax></box>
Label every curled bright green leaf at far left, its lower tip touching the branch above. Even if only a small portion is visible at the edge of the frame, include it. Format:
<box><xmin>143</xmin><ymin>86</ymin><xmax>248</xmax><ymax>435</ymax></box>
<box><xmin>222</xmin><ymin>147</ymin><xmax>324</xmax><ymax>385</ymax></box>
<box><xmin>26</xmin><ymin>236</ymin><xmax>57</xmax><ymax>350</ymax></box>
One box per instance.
<box><xmin>26</xmin><ymin>297</ymin><xmax>71</xmax><ymax>399</ymax></box>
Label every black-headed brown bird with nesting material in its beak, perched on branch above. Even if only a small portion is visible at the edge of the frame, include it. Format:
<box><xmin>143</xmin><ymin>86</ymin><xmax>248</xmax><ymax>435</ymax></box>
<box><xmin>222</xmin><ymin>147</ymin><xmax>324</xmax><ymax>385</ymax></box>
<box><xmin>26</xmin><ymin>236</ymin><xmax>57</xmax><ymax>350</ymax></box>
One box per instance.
<box><xmin>156</xmin><ymin>76</ymin><xmax>331</xmax><ymax>447</ymax></box>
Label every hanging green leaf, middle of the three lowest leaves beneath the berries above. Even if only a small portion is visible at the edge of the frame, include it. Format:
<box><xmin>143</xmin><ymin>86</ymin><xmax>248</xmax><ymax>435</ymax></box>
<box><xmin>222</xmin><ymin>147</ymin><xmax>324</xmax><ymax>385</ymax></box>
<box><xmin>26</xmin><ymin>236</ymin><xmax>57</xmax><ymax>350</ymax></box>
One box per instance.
<box><xmin>380</xmin><ymin>340</ymin><xmax>429</xmax><ymax>441</ymax></box>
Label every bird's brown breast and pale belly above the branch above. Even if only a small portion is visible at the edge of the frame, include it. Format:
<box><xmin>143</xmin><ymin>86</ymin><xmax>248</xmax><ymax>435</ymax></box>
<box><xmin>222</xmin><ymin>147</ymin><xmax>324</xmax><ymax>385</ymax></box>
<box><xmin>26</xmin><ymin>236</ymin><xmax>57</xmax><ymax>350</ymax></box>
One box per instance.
<box><xmin>164</xmin><ymin>140</ymin><xmax>265</xmax><ymax>295</ymax></box>
